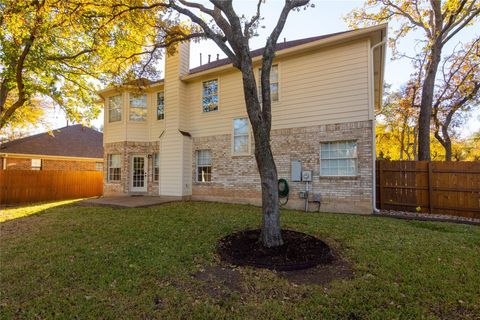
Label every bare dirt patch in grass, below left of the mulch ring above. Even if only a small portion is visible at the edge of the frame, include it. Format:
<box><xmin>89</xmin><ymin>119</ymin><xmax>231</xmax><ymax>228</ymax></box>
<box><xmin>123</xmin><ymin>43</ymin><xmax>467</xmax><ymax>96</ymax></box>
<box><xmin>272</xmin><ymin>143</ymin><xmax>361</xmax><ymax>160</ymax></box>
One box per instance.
<box><xmin>193</xmin><ymin>266</ymin><xmax>244</xmax><ymax>298</ymax></box>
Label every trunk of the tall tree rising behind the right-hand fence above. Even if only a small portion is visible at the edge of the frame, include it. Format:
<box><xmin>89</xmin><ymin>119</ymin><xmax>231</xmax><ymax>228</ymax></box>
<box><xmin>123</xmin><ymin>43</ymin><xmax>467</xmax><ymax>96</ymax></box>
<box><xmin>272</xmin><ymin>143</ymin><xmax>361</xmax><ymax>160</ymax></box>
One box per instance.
<box><xmin>418</xmin><ymin>41</ymin><xmax>442</xmax><ymax>160</ymax></box>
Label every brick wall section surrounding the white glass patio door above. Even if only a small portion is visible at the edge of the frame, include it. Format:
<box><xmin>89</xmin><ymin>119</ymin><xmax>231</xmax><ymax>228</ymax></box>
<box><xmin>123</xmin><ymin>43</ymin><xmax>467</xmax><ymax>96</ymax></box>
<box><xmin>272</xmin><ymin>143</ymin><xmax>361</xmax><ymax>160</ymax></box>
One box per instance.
<box><xmin>103</xmin><ymin>142</ymin><xmax>159</xmax><ymax>196</ymax></box>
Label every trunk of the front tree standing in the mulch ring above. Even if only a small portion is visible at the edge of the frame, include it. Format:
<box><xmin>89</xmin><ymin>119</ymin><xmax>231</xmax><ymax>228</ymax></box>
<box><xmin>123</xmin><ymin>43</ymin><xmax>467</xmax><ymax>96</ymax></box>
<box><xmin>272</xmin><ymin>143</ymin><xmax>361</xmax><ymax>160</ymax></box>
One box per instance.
<box><xmin>241</xmin><ymin>59</ymin><xmax>283</xmax><ymax>248</ymax></box>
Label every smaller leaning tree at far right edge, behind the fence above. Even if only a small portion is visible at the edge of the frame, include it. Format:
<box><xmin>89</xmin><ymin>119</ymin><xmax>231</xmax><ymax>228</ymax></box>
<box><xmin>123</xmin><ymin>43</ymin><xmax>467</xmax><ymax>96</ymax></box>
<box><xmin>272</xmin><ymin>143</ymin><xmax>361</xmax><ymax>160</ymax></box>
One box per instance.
<box><xmin>433</xmin><ymin>39</ymin><xmax>480</xmax><ymax>161</ymax></box>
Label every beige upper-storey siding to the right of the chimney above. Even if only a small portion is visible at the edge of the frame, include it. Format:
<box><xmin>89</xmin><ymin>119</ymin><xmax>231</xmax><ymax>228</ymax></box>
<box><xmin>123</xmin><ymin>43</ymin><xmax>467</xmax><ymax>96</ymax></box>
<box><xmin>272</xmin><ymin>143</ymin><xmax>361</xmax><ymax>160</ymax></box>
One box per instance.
<box><xmin>187</xmin><ymin>40</ymin><xmax>369</xmax><ymax>137</ymax></box>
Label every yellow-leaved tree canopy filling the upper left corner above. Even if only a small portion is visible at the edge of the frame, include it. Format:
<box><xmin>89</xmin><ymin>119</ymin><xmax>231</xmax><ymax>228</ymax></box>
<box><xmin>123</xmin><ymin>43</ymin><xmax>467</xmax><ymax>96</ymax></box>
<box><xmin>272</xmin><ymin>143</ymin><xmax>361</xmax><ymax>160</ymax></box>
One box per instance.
<box><xmin>0</xmin><ymin>0</ymin><xmax>167</xmax><ymax>130</ymax></box>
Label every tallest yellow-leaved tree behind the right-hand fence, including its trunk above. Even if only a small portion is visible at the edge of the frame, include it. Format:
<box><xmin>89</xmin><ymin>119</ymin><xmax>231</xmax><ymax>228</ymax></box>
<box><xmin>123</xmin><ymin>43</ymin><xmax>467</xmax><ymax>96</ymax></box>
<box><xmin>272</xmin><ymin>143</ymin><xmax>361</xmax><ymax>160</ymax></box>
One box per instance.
<box><xmin>347</xmin><ymin>0</ymin><xmax>480</xmax><ymax>160</ymax></box>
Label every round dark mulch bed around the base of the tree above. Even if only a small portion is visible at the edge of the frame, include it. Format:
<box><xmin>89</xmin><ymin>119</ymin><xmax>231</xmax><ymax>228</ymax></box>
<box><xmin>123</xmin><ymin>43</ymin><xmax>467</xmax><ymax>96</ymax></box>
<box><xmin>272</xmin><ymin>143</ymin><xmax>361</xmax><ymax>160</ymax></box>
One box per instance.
<box><xmin>217</xmin><ymin>229</ymin><xmax>333</xmax><ymax>271</ymax></box>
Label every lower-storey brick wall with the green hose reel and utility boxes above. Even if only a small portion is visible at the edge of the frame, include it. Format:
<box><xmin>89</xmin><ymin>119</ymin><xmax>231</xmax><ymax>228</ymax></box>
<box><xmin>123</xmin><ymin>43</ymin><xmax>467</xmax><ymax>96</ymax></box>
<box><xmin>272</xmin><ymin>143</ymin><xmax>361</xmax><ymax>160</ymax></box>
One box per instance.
<box><xmin>192</xmin><ymin>121</ymin><xmax>373</xmax><ymax>213</ymax></box>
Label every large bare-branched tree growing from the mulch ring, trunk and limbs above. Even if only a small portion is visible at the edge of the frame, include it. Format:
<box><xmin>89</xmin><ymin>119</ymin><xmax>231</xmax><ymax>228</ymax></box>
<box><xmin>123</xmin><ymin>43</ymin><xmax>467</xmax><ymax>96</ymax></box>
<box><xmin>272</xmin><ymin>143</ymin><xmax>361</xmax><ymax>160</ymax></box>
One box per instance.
<box><xmin>115</xmin><ymin>0</ymin><xmax>311</xmax><ymax>247</ymax></box>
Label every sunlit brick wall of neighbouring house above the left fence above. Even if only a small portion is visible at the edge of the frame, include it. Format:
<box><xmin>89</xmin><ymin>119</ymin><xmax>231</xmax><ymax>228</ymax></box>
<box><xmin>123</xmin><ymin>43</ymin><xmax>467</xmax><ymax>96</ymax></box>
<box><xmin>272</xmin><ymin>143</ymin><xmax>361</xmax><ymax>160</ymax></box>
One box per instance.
<box><xmin>0</xmin><ymin>157</ymin><xmax>100</xmax><ymax>171</ymax></box>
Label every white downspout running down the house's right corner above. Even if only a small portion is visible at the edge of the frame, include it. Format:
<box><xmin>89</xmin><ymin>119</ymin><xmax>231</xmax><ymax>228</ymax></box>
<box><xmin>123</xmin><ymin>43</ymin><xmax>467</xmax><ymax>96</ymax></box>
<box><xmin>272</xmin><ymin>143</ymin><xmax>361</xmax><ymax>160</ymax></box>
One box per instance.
<box><xmin>369</xmin><ymin>31</ymin><xmax>387</xmax><ymax>214</ymax></box>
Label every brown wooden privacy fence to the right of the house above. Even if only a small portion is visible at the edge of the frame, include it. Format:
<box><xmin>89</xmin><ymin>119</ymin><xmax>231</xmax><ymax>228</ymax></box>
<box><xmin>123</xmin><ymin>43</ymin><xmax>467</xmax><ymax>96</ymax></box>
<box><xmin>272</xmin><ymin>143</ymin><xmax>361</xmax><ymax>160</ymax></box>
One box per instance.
<box><xmin>376</xmin><ymin>160</ymin><xmax>480</xmax><ymax>219</ymax></box>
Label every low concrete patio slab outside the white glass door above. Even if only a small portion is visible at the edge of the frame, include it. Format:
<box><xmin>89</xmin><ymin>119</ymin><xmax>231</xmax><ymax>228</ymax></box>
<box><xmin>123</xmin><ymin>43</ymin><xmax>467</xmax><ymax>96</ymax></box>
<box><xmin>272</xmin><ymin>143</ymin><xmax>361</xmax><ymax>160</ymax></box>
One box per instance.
<box><xmin>77</xmin><ymin>196</ymin><xmax>183</xmax><ymax>208</ymax></box>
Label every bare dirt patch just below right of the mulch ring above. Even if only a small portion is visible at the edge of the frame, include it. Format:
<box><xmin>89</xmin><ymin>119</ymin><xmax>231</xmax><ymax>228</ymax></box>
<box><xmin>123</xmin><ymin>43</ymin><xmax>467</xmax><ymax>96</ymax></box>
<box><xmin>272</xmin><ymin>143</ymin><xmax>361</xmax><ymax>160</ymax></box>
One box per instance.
<box><xmin>278</xmin><ymin>258</ymin><xmax>354</xmax><ymax>286</ymax></box>
